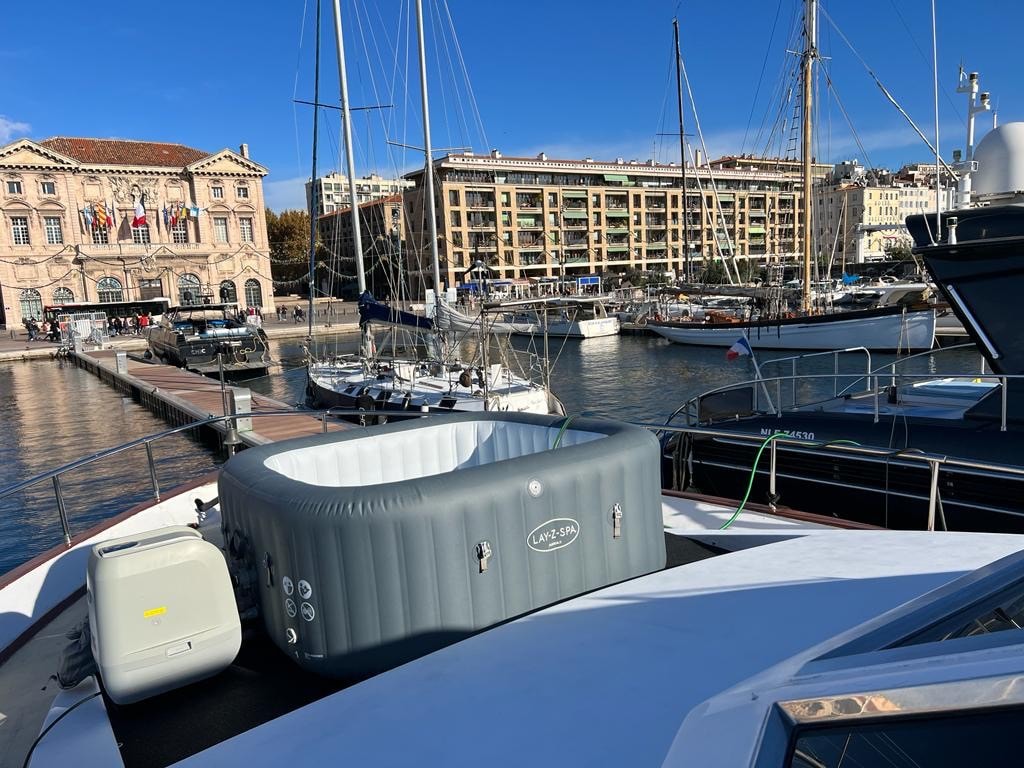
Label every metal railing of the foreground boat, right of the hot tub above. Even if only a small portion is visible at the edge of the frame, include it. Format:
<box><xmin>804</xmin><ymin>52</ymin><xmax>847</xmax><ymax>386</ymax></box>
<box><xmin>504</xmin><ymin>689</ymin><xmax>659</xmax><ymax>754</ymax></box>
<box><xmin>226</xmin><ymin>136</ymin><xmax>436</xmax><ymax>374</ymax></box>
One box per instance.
<box><xmin>638</xmin><ymin>423</ymin><xmax>1024</xmax><ymax>530</ymax></box>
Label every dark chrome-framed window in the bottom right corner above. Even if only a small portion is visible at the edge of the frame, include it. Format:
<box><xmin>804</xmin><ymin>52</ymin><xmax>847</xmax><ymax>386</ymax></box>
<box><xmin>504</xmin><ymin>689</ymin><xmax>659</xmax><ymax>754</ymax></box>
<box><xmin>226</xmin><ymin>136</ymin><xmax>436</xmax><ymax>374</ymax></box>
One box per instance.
<box><xmin>785</xmin><ymin>707</ymin><xmax>1024</xmax><ymax>768</ymax></box>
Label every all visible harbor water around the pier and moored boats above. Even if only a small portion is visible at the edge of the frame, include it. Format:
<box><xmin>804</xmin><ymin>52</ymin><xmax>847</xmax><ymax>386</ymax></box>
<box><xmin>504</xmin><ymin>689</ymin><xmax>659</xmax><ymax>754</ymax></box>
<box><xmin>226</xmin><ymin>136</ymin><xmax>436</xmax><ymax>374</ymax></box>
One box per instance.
<box><xmin>0</xmin><ymin>335</ymin><xmax>979</xmax><ymax>573</ymax></box>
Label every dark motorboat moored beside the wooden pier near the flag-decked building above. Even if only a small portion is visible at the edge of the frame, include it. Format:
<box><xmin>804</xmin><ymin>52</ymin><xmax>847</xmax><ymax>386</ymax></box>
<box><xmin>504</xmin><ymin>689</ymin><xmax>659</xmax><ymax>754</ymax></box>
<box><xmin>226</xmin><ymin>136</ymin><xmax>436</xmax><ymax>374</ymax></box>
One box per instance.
<box><xmin>147</xmin><ymin>303</ymin><xmax>270</xmax><ymax>377</ymax></box>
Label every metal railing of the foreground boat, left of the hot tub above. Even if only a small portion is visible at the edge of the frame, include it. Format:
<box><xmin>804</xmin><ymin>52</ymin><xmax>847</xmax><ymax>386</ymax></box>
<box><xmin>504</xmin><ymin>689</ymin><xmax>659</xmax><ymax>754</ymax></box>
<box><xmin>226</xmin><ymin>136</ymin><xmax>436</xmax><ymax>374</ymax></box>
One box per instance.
<box><xmin>0</xmin><ymin>408</ymin><xmax>419</xmax><ymax>546</ymax></box>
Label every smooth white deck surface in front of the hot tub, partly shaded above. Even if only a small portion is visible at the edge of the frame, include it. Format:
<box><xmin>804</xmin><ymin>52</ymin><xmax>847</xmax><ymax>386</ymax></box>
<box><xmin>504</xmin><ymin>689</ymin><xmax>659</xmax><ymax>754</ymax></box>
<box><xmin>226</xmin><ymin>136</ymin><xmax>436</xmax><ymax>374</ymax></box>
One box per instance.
<box><xmin>182</xmin><ymin>531</ymin><xmax>1024</xmax><ymax>768</ymax></box>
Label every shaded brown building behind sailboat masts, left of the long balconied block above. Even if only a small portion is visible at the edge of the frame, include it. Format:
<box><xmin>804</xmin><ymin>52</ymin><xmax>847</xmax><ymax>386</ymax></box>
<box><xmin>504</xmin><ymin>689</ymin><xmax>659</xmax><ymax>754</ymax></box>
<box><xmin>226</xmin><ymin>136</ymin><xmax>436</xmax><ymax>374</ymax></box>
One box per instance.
<box><xmin>316</xmin><ymin>195</ymin><xmax>410</xmax><ymax>299</ymax></box>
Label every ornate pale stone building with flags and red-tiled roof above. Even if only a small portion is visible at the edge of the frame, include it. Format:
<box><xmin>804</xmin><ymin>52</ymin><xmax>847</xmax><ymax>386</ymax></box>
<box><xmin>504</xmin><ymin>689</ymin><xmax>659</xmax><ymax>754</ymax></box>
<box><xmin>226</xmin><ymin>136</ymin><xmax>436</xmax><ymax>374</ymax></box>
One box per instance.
<box><xmin>0</xmin><ymin>137</ymin><xmax>273</xmax><ymax>328</ymax></box>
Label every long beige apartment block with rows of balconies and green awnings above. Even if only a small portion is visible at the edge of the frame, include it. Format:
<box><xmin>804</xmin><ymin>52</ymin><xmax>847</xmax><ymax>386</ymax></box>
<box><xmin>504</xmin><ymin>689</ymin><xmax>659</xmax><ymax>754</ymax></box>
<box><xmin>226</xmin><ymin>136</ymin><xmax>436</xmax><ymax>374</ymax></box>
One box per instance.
<box><xmin>406</xmin><ymin>151</ymin><xmax>823</xmax><ymax>287</ymax></box>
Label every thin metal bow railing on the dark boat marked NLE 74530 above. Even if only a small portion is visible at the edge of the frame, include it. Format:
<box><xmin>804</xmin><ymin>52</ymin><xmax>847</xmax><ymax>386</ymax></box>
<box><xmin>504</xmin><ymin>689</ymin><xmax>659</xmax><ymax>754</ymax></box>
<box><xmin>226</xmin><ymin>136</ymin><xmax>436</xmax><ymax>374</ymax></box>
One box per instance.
<box><xmin>665</xmin><ymin>367</ymin><xmax>1024</xmax><ymax>432</ymax></box>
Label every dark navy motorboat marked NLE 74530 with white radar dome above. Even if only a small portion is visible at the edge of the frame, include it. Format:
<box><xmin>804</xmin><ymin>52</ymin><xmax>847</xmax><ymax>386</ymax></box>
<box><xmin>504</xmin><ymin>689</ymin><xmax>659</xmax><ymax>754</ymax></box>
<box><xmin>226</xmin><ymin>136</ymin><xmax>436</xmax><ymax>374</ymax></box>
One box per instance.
<box><xmin>667</xmin><ymin>107</ymin><xmax>1024</xmax><ymax>532</ymax></box>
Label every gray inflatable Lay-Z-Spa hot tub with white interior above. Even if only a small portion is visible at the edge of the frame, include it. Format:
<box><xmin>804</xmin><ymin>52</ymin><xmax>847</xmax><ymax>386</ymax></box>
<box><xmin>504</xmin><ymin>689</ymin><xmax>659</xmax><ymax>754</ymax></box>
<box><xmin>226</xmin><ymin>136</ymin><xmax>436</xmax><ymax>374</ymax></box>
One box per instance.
<box><xmin>218</xmin><ymin>414</ymin><xmax>666</xmax><ymax>678</ymax></box>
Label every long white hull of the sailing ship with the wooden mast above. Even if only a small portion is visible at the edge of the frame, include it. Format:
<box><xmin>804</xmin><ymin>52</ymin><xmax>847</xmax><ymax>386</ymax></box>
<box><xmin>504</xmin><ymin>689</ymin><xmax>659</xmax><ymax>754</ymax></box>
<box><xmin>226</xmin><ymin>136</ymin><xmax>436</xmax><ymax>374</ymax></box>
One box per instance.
<box><xmin>647</xmin><ymin>310</ymin><xmax>935</xmax><ymax>351</ymax></box>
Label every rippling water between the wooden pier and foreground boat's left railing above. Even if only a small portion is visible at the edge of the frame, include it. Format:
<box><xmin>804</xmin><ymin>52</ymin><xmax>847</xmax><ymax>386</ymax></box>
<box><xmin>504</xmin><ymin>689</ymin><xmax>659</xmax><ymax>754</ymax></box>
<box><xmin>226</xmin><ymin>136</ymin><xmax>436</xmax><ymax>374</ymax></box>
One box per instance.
<box><xmin>0</xmin><ymin>360</ymin><xmax>217</xmax><ymax>572</ymax></box>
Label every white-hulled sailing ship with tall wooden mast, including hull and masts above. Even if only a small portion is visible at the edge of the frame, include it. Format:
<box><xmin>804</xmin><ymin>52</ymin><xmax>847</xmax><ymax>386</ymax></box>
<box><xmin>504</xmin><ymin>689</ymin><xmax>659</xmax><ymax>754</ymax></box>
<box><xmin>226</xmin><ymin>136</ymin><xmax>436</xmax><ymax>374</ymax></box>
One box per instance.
<box><xmin>647</xmin><ymin>0</ymin><xmax>936</xmax><ymax>351</ymax></box>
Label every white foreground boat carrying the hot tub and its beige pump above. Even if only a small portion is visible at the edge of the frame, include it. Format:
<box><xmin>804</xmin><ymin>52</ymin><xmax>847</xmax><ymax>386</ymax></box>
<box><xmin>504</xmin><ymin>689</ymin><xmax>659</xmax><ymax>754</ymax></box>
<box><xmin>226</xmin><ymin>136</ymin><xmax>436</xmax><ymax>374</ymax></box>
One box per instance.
<box><xmin>0</xmin><ymin>405</ymin><xmax>1024</xmax><ymax>768</ymax></box>
